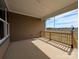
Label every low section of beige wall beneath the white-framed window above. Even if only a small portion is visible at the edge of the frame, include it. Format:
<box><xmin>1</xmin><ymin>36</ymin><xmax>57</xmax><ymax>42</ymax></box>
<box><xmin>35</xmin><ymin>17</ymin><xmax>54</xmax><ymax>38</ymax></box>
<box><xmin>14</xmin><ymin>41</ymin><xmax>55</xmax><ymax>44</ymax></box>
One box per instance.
<box><xmin>0</xmin><ymin>38</ymin><xmax>9</xmax><ymax>59</ymax></box>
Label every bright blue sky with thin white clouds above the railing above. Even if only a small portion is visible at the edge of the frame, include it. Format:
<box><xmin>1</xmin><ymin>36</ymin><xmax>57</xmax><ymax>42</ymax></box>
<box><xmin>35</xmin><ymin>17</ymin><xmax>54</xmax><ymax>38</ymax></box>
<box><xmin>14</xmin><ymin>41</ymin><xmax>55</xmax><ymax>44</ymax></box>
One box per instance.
<box><xmin>45</xmin><ymin>9</ymin><xmax>78</xmax><ymax>28</ymax></box>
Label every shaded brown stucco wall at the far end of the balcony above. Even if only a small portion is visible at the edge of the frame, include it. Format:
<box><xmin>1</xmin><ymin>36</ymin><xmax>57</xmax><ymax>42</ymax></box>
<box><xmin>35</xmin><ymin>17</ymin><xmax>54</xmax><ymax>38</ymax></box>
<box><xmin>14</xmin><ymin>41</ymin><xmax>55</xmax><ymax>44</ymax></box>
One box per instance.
<box><xmin>8</xmin><ymin>13</ymin><xmax>44</xmax><ymax>41</ymax></box>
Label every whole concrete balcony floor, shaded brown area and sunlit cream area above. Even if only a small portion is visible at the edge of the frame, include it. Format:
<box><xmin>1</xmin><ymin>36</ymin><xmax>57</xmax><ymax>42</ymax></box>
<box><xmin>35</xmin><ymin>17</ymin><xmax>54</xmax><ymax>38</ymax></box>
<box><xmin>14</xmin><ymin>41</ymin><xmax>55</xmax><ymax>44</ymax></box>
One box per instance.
<box><xmin>4</xmin><ymin>39</ymin><xmax>78</xmax><ymax>59</ymax></box>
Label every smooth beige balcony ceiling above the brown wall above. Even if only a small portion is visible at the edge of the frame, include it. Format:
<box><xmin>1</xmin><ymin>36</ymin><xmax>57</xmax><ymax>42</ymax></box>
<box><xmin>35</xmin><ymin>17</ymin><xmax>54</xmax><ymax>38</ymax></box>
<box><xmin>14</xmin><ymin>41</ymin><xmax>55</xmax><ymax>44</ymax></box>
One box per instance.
<box><xmin>5</xmin><ymin>0</ymin><xmax>77</xmax><ymax>18</ymax></box>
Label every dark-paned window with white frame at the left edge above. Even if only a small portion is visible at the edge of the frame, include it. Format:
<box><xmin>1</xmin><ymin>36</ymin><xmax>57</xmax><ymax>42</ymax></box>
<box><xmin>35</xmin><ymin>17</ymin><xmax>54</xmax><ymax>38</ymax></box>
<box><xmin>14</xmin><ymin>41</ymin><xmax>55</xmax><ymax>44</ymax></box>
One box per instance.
<box><xmin>0</xmin><ymin>0</ymin><xmax>9</xmax><ymax>40</ymax></box>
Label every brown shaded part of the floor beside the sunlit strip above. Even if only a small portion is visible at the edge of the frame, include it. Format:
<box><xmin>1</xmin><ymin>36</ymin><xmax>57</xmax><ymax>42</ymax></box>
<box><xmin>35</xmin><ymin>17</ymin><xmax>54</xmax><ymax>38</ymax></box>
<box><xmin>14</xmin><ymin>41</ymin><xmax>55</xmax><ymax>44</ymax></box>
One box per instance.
<box><xmin>4</xmin><ymin>40</ymin><xmax>50</xmax><ymax>59</ymax></box>
